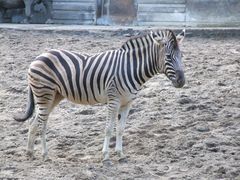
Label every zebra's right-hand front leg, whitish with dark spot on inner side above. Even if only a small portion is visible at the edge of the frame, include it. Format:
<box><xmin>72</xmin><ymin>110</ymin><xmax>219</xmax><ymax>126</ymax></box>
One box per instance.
<box><xmin>115</xmin><ymin>103</ymin><xmax>131</xmax><ymax>160</ymax></box>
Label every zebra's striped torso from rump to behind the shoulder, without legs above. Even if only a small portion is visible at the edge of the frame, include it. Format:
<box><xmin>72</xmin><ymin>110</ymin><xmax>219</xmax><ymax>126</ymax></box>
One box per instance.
<box><xmin>28</xmin><ymin>50</ymin><xmax>117</xmax><ymax>104</ymax></box>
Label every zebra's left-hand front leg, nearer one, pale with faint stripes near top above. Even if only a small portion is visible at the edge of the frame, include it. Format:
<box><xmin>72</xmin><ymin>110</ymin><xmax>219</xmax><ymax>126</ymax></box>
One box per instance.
<box><xmin>102</xmin><ymin>100</ymin><xmax>120</xmax><ymax>162</ymax></box>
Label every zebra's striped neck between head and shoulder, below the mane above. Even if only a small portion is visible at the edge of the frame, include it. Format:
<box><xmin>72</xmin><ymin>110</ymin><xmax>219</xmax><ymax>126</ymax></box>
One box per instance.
<box><xmin>122</xmin><ymin>34</ymin><xmax>160</xmax><ymax>86</ymax></box>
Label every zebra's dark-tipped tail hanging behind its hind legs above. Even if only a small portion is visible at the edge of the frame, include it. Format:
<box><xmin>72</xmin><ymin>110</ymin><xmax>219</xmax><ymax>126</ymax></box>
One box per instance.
<box><xmin>13</xmin><ymin>87</ymin><xmax>35</xmax><ymax>122</ymax></box>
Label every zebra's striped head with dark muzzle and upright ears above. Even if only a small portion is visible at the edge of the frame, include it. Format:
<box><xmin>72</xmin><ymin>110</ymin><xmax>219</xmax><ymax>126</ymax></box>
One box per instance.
<box><xmin>151</xmin><ymin>30</ymin><xmax>185</xmax><ymax>88</ymax></box>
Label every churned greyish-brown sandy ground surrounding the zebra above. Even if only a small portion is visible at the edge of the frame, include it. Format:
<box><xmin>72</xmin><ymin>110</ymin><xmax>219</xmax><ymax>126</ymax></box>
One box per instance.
<box><xmin>0</xmin><ymin>27</ymin><xmax>240</xmax><ymax>180</ymax></box>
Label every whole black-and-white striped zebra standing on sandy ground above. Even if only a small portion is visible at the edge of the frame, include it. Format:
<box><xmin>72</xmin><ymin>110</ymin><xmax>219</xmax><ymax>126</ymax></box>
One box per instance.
<box><xmin>14</xmin><ymin>30</ymin><xmax>185</xmax><ymax>162</ymax></box>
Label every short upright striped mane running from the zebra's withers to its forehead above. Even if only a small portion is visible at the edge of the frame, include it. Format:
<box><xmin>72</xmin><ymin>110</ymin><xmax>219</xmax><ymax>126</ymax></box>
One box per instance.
<box><xmin>121</xmin><ymin>29</ymin><xmax>178</xmax><ymax>48</ymax></box>
